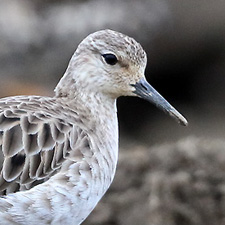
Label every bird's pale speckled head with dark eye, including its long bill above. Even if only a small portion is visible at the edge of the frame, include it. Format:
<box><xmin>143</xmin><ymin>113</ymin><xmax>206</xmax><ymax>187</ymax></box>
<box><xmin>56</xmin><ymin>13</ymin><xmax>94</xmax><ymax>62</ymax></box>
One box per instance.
<box><xmin>56</xmin><ymin>30</ymin><xmax>187</xmax><ymax>125</ymax></box>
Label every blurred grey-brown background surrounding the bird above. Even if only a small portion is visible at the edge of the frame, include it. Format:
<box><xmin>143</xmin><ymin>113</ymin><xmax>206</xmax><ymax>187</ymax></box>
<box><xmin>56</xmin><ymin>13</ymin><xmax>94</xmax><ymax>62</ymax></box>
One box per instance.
<box><xmin>0</xmin><ymin>0</ymin><xmax>225</xmax><ymax>225</ymax></box>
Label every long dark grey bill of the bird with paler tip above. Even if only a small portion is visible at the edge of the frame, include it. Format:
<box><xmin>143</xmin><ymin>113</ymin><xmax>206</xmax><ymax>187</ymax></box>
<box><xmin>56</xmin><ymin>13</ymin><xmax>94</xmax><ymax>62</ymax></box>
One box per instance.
<box><xmin>131</xmin><ymin>78</ymin><xmax>188</xmax><ymax>126</ymax></box>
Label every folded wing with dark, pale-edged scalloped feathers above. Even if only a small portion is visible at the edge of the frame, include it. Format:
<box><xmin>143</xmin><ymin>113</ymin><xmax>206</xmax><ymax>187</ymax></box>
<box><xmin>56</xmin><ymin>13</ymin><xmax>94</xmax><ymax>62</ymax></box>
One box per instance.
<box><xmin>0</xmin><ymin>97</ymin><xmax>85</xmax><ymax>195</ymax></box>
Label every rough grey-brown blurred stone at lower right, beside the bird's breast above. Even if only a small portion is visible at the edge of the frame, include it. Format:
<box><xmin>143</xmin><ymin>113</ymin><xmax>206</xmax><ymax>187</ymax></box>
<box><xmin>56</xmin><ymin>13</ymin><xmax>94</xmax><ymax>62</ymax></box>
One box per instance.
<box><xmin>84</xmin><ymin>137</ymin><xmax>225</xmax><ymax>225</ymax></box>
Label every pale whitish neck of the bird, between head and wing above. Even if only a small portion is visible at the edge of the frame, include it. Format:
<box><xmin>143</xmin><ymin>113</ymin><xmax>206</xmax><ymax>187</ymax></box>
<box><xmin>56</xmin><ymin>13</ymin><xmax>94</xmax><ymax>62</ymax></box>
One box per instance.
<box><xmin>56</xmin><ymin>75</ymin><xmax>118</xmax><ymax>176</ymax></box>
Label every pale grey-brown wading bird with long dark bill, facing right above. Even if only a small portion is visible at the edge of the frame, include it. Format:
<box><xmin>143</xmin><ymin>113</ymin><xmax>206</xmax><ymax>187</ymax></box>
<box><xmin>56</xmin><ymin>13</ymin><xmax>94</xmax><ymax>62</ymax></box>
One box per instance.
<box><xmin>0</xmin><ymin>29</ymin><xmax>188</xmax><ymax>225</ymax></box>
